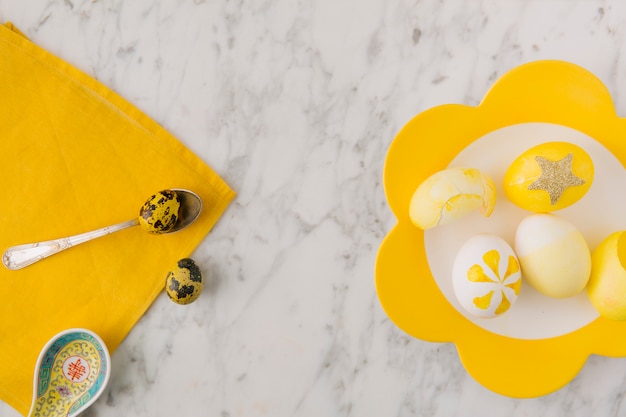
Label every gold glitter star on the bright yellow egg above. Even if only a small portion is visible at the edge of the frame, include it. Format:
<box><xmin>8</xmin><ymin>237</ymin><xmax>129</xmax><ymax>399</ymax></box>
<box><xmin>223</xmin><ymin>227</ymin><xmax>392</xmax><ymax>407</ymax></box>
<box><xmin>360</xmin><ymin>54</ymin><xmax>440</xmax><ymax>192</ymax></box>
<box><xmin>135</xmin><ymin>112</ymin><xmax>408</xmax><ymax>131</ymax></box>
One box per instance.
<box><xmin>528</xmin><ymin>153</ymin><xmax>585</xmax><ymax>205</ymax></box>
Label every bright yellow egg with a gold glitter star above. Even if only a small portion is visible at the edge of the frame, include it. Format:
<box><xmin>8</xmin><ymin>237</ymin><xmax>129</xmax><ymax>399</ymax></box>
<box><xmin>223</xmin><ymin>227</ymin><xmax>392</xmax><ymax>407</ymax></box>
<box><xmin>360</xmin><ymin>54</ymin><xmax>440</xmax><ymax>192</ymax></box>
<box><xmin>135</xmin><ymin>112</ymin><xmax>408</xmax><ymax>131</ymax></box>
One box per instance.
<box><xmin>503</xmin><ymin>142</ymin><xmax>594</xmax><ymax>213</ymax></box>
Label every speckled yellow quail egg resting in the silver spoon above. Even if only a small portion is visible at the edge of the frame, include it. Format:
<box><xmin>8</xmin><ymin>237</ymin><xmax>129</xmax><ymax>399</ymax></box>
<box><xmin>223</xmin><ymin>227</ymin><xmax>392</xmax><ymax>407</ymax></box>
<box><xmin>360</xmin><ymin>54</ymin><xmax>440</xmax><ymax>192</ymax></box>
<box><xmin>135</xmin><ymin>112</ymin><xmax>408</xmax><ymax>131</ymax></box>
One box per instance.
<box><xmin>139</xmin><ymin>190</ymin><xmax>180</xmax><ymax>234</ymax></box>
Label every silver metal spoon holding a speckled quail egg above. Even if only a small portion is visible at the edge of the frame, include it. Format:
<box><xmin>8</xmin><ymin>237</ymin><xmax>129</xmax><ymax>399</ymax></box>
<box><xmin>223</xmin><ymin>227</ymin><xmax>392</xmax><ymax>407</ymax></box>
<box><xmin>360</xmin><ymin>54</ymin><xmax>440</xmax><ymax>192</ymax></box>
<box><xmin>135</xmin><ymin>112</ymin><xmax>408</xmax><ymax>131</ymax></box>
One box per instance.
<box><xmin>2</xmin><ymin>188</ymin><xmax>202</xmax><ymax>270</ymax></box>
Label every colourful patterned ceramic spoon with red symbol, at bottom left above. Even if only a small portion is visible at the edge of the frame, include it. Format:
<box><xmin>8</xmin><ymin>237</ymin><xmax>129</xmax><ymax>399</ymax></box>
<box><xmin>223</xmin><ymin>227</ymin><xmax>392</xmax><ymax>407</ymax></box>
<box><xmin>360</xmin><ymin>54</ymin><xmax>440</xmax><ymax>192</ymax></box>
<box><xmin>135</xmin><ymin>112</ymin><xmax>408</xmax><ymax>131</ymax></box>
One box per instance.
<box><xmin>28</xmin><ymin>329</ymin><xmax>111</xmax><ymax>417</ymax></box>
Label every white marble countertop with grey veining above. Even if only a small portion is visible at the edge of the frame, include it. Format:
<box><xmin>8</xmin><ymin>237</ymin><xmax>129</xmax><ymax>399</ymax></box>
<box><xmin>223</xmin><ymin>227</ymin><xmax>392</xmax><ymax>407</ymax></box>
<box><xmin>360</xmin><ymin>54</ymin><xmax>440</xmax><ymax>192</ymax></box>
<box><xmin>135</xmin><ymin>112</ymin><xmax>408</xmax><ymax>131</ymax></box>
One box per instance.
<box><xmin>0</xmin><ymin>0</ymin><xmax>626</xmax><ymax>417</ymax></box>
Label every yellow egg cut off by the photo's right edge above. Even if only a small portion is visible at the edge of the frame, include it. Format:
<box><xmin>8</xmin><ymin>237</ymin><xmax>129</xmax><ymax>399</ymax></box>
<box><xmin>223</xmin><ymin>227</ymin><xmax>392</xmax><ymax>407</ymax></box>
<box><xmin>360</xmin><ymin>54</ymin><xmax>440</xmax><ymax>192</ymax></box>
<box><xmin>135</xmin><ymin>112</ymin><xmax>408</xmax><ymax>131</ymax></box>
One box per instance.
<box><xmin>587</xmin><ymin>231</ymin><xmax>626</xmax><ymax>320</ymax></box>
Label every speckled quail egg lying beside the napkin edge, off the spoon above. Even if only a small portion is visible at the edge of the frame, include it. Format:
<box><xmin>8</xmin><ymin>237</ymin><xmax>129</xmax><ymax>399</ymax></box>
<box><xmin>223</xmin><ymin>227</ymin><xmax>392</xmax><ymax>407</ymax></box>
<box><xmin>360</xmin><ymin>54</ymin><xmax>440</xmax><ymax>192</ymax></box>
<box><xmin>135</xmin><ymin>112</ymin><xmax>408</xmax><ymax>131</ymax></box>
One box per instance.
<box><xmin>165</xmin><ymin>258</ymin><xmax>204</xmax><ymax>304</ymax></box>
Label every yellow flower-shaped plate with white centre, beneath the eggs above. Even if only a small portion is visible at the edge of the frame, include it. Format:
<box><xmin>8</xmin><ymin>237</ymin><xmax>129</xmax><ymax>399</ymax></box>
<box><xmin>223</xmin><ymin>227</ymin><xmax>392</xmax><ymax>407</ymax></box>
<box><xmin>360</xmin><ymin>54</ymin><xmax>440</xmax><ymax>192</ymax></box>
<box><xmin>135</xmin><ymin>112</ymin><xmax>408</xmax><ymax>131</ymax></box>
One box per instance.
<box><xmin>376</xmin><ymin>61</ymin><xmax>626</xmax><ymax>398</ymax></box>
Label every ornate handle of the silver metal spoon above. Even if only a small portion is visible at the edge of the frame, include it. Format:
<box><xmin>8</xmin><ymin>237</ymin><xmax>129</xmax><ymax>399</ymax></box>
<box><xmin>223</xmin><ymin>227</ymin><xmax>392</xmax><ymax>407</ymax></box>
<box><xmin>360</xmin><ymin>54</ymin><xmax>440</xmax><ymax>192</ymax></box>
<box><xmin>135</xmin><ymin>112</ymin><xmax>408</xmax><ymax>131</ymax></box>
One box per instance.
<box><xmin>2</xmin><ymin>219</ymin><xmax>139</xmax><ymax>270</ymax></box>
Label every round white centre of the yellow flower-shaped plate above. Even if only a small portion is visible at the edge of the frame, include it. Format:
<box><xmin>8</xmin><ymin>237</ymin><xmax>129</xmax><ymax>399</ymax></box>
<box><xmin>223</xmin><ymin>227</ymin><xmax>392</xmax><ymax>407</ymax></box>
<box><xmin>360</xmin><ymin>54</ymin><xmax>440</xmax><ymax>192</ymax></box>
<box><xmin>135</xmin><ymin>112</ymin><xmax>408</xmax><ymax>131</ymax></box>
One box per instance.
<box><xmin>424</xmin><ymin>123</ymin><xmax>626</xmax><ymax>339</ymax></box>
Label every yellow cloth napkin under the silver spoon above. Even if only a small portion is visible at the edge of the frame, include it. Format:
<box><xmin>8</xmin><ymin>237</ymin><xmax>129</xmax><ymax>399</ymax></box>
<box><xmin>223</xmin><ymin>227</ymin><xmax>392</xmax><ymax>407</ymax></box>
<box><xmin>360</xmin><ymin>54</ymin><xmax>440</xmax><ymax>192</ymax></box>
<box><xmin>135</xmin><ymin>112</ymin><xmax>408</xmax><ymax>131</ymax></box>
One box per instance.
<box><xmin>0</xmin><ymin>24</ymin><xmax>234</xmax><ymax>414</ymax></box>
